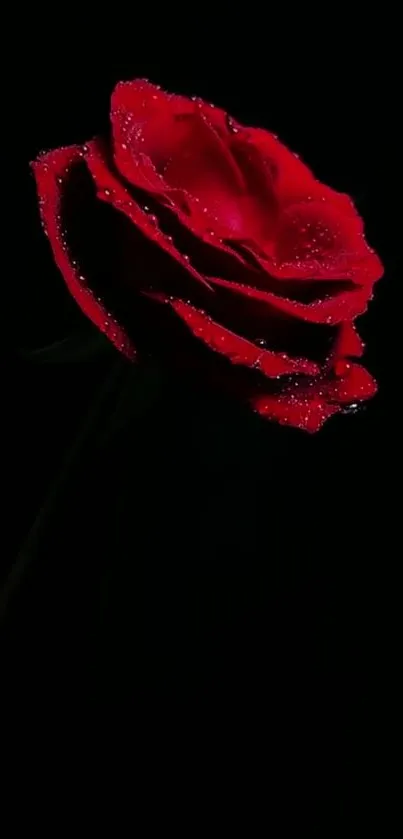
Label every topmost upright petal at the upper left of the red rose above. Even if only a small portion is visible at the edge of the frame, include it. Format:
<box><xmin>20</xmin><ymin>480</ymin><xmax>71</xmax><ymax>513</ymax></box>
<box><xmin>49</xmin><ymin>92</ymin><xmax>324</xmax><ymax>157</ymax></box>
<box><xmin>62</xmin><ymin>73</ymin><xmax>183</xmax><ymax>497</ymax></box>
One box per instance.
<box><xmin>111</xmin><ymin>81</ymin><xmax>244</xmax><ymax>216</ymax></box>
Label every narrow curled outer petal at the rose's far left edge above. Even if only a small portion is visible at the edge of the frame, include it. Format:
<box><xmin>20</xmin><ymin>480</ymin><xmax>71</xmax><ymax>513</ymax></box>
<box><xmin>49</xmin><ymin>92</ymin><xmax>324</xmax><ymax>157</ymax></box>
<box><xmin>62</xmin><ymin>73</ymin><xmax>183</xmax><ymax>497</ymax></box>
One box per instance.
<box><xmin>32</xmin><ymin>146</ymin><xmax>135</xmax><ymax>358</ymax></box>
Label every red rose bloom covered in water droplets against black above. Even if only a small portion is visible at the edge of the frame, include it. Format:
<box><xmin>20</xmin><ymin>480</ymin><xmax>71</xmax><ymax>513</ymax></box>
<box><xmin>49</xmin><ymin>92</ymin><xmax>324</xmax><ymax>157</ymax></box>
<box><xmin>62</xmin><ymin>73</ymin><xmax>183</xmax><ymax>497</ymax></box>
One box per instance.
<box><xmin>34</xmin><ymin>81</ymin><xmax>382</xmax><ymax>431</ymax></box>
